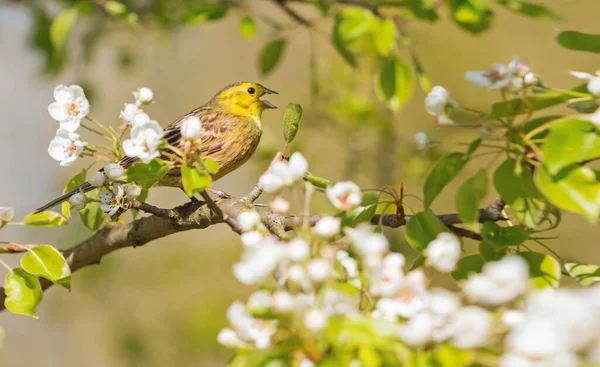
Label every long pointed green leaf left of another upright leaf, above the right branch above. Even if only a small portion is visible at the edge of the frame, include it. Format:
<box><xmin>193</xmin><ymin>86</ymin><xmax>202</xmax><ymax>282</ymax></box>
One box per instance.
<box><xmin>423</xmin><ymin>152</ymin><xmax>468</xmax><ymax>207</ymax></box>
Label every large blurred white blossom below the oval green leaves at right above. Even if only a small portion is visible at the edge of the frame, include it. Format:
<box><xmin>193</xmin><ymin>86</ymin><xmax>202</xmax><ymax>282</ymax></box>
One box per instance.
<box><xmin>463</xmin><ymin>255</ymin><xmax>529</xmax><ymax>305</ymax></box>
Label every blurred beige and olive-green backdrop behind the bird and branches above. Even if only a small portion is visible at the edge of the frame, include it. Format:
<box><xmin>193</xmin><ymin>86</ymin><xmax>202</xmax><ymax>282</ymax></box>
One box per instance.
<box><xmin>0</xmin><ymin>0</ymin><xmax>600</xmax><ymax>367</ymax></box>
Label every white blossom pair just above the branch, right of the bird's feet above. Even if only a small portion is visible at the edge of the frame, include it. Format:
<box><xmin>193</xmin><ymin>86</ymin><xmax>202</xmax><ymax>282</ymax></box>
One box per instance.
<box><xmin>258</xmin><ymin>152</ymin><xmax>308</xmax><ymax>192</ymax></box>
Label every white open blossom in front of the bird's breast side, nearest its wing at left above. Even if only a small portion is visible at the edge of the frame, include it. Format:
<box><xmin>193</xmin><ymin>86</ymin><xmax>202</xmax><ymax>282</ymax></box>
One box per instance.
<box><xmin>123</xmin><ymin>113</ymin><xmax>163</xmax><ymax>163</ymax></box>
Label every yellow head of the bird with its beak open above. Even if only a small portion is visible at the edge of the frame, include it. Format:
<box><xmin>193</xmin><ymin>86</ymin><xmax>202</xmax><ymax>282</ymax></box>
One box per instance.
<box><xmin>208</xmin><ymin>82</ymin><xmax>279</xmax><ymax>119</ymax></box>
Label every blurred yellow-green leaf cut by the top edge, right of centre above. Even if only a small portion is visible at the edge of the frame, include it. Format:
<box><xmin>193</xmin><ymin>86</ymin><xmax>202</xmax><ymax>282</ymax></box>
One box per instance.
<box><xmin>447</xmin><ymin>0</ymin><xmax>493</xmax><ymax>34</ymax></box>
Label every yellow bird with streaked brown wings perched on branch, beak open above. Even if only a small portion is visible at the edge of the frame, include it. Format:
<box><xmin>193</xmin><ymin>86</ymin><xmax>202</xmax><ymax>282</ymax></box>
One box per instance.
<box><xmin>36</xmin><ymin>82</ymin><xmax>278</xmax><ymax>213</ymax></box>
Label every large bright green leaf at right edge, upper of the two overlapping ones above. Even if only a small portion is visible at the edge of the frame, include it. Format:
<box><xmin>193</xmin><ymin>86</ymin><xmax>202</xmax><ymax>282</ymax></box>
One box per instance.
<box><xmin>542</xmin><ymin>119</ymin><xmax>600</xmax><ymax>175</ymax></box>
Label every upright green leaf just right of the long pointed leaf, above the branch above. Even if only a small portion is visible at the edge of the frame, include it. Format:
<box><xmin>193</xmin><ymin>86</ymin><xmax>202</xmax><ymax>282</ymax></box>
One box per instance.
<box><xmin>456</xmin><ymin>169</ymin><xmax>488</xmax><ymax>228</ymax></box>
